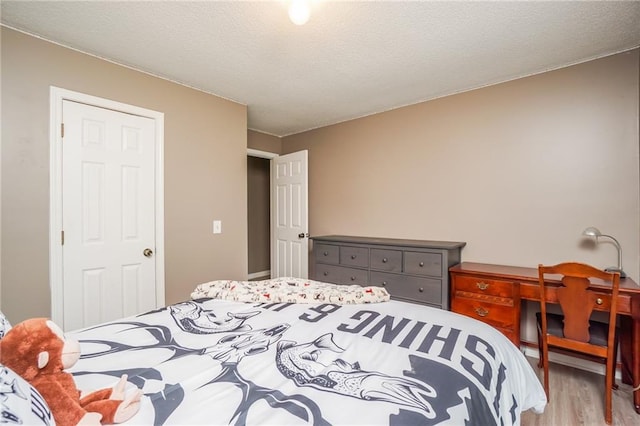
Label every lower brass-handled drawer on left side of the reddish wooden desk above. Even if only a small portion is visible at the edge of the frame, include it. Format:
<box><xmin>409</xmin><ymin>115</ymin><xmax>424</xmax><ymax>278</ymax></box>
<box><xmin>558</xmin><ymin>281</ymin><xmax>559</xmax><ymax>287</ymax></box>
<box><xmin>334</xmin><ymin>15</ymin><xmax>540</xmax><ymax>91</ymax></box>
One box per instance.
<box><xmin>451</xmin><ymin>296</ymin><xmax>520</xmax><ymax>330</ymax></box>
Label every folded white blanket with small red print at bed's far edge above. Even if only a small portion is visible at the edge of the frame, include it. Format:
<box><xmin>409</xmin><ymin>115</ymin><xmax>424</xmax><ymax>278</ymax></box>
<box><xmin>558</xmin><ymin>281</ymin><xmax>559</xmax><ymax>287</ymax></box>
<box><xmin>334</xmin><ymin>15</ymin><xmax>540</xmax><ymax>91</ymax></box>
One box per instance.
<box><xmin>191</xmin><ymin>278</ymin><xmax>389</xmax><ymax>305</ymax></box>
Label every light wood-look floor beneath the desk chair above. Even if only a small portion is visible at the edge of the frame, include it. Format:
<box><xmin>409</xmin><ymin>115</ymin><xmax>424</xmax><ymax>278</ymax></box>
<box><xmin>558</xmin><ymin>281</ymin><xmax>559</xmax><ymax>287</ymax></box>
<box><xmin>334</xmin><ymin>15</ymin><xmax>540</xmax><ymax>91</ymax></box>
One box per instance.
<box><xmin>521</xmin><ymin>357</ymin><xmax>640</xmax><ymax>426</ymax></box>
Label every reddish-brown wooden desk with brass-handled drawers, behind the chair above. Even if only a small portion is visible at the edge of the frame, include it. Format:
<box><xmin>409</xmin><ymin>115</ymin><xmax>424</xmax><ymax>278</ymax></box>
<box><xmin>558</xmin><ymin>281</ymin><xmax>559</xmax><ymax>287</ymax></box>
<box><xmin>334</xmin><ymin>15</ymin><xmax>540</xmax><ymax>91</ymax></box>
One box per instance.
<box><xmin>449</xmin><ymin>262</ymin><xmax>640</xmax><ymax>414</ymax></box>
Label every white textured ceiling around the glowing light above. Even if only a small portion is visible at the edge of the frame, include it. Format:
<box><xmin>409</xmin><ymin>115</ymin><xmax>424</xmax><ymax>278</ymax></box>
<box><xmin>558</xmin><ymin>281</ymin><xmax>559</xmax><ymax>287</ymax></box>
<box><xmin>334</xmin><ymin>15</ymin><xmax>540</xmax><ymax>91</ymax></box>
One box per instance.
<box><xmin>0</xmin><ymin>0</ymin><xmax>640</xmax><ymax>136</ymax></box>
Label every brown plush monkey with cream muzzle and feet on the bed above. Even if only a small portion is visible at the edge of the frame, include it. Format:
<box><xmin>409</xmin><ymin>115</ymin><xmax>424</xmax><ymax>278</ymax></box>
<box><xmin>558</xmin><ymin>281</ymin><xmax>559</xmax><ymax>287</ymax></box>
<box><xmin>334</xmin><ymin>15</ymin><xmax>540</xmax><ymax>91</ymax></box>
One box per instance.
<box><xmin>0</xmin><ymin>318</ymin><xmax>142</xmax><ymax>426</ymax></box>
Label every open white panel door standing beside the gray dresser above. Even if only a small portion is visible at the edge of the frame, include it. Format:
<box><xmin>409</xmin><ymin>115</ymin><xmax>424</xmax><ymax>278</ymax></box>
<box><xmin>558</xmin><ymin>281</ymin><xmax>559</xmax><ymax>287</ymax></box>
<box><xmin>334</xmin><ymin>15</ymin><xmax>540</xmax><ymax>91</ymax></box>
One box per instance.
<box><xmin>271</xmin><ymin>150</ymin><xmax>309</xmax><ymax>278</ymax></box>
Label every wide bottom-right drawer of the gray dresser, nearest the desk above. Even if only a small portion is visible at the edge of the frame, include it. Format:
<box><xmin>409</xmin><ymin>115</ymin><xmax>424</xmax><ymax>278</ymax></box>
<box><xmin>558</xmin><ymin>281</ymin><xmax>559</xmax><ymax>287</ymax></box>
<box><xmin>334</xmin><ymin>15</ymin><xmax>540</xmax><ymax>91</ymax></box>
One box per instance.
<box><xmin>371</xmin><ymin>271</ymin><xmax>442</xmax><ymax>306</ymax></box>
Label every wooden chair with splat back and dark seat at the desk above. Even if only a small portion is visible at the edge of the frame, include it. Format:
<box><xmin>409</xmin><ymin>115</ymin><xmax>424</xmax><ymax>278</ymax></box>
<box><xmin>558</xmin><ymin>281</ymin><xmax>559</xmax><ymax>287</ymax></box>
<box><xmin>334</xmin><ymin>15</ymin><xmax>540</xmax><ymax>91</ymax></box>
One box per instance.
<box><xmin>536</xmin><ymin>262</ymin><xmax>620</xmax><ymax>424</ymax></box>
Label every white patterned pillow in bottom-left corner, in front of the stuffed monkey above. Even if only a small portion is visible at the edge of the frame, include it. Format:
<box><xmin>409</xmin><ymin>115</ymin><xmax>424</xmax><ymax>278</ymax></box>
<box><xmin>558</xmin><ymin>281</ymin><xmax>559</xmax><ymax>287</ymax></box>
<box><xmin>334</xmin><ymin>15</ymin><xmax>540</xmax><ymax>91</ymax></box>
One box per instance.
<box><xmin>0</xmin><ymin>364</ymin><xmax>56</xmax><ymax>425</ymax></box>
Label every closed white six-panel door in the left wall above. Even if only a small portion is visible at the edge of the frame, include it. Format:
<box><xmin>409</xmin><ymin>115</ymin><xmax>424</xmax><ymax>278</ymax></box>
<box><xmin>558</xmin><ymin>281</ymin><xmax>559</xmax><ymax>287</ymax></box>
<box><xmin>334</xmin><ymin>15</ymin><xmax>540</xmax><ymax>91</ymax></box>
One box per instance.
<box><xmin>62</xmin><ymin>100</ymin><xmax>156</xmax><ymax>330</ymax></box>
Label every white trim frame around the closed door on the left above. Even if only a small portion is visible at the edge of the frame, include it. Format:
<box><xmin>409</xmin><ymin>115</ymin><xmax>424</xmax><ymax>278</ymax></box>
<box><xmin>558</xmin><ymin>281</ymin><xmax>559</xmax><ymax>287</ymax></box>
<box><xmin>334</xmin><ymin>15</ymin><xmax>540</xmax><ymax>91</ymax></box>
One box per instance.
<box><xmin>49</xmin><ymin>86</ymin><xmax>165</xmax><ymax>324</ymax></box>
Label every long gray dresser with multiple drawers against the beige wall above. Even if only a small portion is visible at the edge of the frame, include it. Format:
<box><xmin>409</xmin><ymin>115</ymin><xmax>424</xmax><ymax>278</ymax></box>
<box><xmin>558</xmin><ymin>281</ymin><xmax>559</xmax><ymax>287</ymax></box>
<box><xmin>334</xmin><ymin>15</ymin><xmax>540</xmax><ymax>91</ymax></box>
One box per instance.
<box><xmin>311</xmin><ymin>235</ymin><xmax>466</xmax><ymax>310</ymax></box>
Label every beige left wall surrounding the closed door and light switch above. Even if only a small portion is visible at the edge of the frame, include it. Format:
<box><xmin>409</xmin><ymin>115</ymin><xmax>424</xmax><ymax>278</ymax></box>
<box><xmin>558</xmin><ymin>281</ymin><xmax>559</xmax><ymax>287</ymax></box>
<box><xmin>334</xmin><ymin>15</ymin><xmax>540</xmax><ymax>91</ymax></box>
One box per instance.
<box><xmin>1</xmin><ymin>28</ymin><xmax>247</xmax><ymax>322</ymax></box>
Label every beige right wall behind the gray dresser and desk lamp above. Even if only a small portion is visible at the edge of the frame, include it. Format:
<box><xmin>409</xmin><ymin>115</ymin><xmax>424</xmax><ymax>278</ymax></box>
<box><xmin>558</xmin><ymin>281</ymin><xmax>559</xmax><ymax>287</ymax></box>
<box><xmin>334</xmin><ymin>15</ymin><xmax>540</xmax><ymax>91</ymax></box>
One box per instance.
<box><xmin>283</xmin><ymin>50</ymin><xmax>640</xmax><ymax>341</ymax></box>
